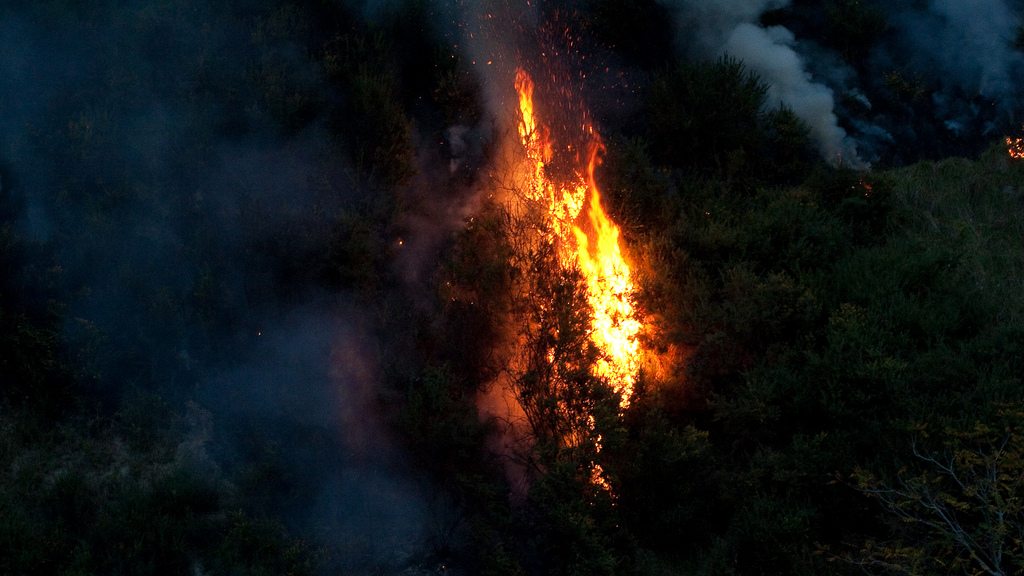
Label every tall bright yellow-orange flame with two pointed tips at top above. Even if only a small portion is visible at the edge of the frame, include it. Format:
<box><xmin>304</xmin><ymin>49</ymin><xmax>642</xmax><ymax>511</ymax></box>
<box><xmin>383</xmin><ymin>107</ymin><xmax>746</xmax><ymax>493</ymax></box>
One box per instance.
<box><xmin>515</xmin><ymin>69</ymin><xmax>641</xmax><ymax>408</ymax></box>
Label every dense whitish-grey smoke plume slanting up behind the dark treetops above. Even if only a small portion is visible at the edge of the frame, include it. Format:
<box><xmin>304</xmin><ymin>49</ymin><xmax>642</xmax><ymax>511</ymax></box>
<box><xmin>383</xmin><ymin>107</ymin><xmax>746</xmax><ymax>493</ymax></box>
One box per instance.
<box><xmin>660</xmin><ymin>0</ymin><xmax>866</xmax><ymax>168</ymax></box>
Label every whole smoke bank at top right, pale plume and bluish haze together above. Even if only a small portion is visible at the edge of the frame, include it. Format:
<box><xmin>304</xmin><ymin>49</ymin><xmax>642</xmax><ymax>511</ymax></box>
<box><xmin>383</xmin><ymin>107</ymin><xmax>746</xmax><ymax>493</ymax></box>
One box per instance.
<box><xmin>651</xmin><ymin>0</ymin><xmax>1024</xmax><ymax>166</ymax></box>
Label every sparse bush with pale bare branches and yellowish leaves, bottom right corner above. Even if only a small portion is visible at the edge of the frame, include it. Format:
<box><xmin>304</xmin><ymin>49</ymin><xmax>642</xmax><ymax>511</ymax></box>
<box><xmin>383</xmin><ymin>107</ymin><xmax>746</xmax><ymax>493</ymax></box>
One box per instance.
<box><xmin>847</xmin><ymin>408</ymin><xmax>1024</xmax><ymax>575</ymax></box>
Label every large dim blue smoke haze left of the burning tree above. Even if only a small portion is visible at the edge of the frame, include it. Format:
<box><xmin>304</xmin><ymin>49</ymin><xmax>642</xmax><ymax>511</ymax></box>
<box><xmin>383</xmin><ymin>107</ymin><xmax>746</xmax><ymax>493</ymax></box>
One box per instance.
<box><xmin>0</xmin><ymin>0</ymin><xmax>456</xmax><ymax>570</ymax></box>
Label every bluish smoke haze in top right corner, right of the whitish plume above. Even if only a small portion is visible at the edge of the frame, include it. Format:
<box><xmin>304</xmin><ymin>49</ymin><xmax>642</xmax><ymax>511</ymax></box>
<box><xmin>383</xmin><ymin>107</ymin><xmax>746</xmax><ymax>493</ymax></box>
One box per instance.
<box><xmin>846</xmin><ymin>0</ymin><xmax>1024</xmax><ymax>159</ymax></box>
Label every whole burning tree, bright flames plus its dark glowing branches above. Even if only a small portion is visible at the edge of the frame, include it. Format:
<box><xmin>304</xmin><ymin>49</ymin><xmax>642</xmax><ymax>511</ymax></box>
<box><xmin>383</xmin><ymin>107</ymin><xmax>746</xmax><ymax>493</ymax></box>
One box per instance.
<box><xmin>468</xmin><ymin>70</ymin><xmax>641</xmax><ymax>501</ymax></box>
